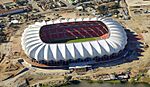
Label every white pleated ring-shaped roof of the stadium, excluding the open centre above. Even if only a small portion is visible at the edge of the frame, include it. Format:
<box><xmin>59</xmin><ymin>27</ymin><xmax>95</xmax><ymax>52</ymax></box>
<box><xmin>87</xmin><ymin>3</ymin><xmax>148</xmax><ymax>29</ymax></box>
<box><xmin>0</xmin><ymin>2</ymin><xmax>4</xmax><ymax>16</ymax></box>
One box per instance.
<box><xmin>21</xmin><ymin>18</ymin><xmax>127</xmax><ymax>61</ymax></box>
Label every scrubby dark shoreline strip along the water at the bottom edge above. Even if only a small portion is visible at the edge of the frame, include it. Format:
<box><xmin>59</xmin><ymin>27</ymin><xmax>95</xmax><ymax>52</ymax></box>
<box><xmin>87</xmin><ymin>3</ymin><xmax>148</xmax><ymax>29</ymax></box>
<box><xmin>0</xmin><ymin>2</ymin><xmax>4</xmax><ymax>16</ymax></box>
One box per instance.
<box><xmin>31</xmin><ymin>79</ymin><xmax>150</xmax><ymax>87</ymax></box>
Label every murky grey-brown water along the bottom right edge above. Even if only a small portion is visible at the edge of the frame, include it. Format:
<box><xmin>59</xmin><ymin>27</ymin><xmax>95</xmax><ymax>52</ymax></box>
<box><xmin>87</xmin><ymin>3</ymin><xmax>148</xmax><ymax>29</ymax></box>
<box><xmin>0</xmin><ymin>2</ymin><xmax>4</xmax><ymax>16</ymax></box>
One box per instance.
<box><xmin>64</xmin><ymin>81</ymin><xmax>150</xmax><ymax>87</ymax></box>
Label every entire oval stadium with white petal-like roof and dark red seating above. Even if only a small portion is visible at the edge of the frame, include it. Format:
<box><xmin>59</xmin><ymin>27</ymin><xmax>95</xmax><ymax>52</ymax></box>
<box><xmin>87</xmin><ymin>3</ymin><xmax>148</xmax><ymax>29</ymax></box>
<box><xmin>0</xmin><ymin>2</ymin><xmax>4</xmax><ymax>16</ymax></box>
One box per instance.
<box><xmin>21</xmin><ymin>18</ymin><xmax>127</xmax><ymax>66</ymax></box>
